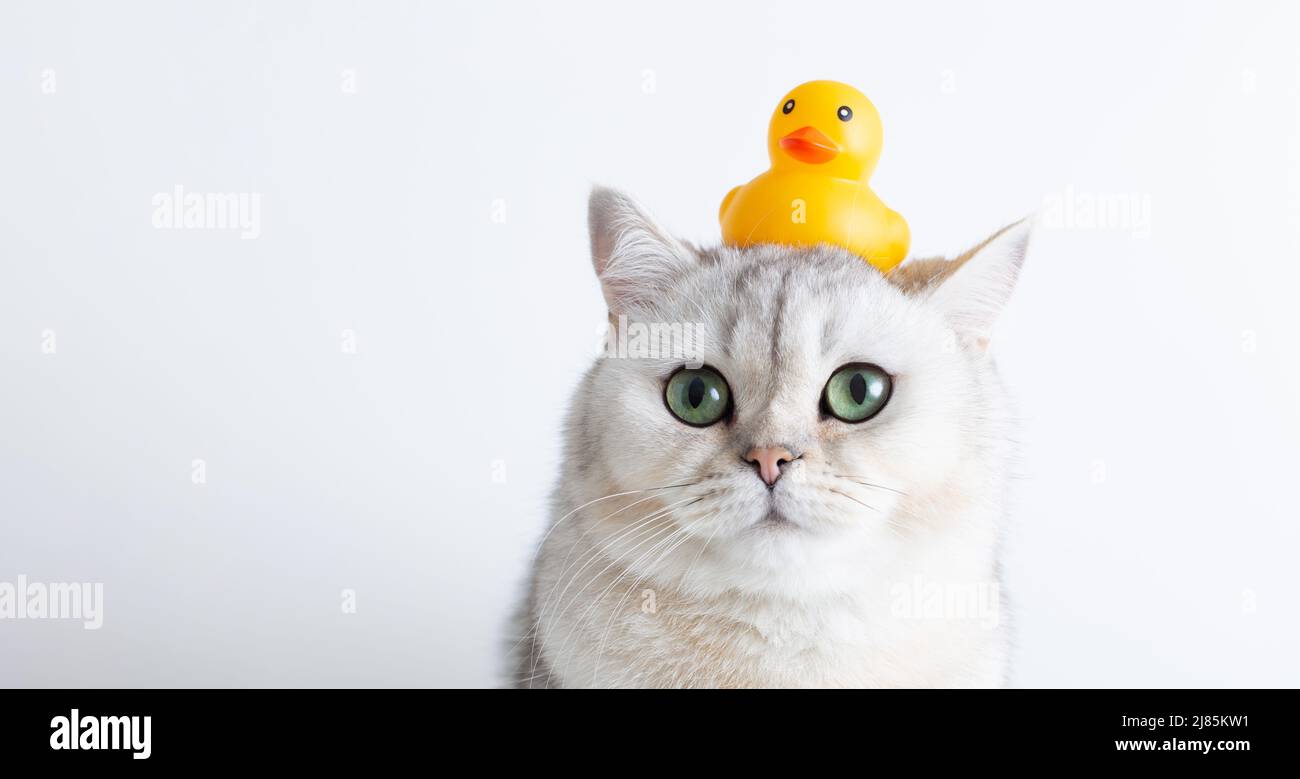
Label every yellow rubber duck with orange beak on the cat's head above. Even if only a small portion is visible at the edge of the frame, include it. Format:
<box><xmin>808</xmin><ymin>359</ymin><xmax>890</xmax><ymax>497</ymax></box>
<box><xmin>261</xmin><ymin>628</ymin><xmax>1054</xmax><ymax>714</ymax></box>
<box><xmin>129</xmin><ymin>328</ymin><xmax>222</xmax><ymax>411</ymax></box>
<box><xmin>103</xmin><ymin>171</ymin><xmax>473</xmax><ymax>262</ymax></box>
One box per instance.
<box><xmin>718</xmin><ymin>81</ymin><xmax>911</xmax><ymax>273</ymax></box>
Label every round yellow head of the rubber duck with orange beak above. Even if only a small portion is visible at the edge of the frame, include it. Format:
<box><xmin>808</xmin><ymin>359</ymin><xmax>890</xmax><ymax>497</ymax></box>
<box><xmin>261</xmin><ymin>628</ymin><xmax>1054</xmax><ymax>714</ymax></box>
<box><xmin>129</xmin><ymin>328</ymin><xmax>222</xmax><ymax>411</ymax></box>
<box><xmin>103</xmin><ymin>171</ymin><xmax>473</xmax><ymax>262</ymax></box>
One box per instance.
<box><xmin>767</xmin><ymin>81</ymin><xmax>883</xmax><ymax>181</ymax></box>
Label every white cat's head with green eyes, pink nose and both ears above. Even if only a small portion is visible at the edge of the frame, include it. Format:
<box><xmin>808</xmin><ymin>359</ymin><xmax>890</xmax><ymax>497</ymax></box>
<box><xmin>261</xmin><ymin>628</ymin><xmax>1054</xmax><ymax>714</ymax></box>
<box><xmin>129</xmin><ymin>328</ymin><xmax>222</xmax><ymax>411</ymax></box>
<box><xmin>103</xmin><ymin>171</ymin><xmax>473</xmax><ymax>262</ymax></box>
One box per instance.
<box><xmin>568</xmin><ymin>189</ymin><xmax>1028</xmax><ymax>598</ymax></box>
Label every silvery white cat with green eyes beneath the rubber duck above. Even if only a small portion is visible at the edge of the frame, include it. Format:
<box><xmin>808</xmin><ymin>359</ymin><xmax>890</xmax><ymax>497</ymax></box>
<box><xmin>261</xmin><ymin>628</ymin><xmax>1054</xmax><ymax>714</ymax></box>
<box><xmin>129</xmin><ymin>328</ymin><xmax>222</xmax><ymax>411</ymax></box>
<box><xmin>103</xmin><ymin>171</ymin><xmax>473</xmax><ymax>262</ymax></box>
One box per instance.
<box><xmin>510</xmin><ymin>187</ymin><xmax>1031</xmax><ymax>688</ymax></box>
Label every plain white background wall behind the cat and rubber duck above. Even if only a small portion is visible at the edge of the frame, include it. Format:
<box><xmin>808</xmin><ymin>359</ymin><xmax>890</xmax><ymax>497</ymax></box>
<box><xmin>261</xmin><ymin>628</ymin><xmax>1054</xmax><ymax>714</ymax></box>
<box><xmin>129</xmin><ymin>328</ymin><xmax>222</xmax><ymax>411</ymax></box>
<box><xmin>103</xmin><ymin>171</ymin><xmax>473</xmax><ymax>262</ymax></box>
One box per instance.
<box><xmin>0</xmin><ymin>1</ymin><xmax>1300</xmax><ymax>687</ymax></box>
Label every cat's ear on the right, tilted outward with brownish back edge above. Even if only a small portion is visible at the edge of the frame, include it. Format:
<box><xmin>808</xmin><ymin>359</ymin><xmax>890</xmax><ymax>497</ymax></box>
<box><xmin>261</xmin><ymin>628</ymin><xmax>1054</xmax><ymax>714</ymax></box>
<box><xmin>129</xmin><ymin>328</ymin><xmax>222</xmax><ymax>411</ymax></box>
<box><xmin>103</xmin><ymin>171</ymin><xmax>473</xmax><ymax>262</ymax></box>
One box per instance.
<box><xmin>930</xmin><ymin>218</ymin><xmax>1034</xmax><ymax>349</ymax></box>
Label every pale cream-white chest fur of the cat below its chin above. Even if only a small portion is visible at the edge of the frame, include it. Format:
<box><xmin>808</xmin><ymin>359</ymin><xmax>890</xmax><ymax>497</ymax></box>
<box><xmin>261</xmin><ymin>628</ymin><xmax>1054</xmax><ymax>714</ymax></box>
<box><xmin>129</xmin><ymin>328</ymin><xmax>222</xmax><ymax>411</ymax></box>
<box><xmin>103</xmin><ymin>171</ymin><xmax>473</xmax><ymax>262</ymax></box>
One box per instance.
<box><xmin>522</xmin><ymin>520</ymin><xmax>1006</xmax><ymax>688</ymax></box>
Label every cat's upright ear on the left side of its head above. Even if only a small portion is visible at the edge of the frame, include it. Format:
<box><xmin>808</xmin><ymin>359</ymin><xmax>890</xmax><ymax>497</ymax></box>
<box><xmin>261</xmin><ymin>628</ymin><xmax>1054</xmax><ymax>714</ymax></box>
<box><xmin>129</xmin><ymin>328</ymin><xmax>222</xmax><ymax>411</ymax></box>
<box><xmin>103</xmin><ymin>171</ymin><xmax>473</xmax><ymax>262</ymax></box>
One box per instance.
<box><xmin>588</xmin><ymin>187</ymin><xmax>696</xmax><ymax>315</ymax></box>
